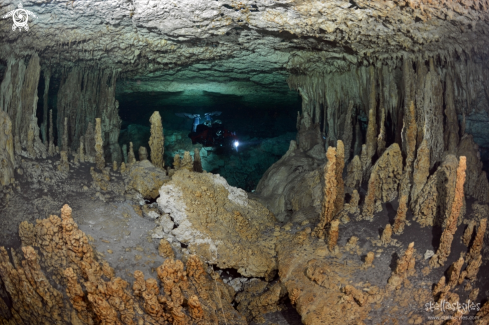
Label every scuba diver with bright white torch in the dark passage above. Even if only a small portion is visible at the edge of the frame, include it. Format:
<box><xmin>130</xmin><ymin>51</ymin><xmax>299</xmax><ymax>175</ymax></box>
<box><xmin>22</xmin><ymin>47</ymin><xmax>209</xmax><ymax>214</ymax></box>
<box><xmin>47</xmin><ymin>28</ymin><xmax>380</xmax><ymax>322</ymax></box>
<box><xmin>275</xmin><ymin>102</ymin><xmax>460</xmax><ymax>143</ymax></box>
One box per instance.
<box><xmin>175</xmin><ymin>111</ymin><xmax>239</xmax><ymax>151</ymax></box>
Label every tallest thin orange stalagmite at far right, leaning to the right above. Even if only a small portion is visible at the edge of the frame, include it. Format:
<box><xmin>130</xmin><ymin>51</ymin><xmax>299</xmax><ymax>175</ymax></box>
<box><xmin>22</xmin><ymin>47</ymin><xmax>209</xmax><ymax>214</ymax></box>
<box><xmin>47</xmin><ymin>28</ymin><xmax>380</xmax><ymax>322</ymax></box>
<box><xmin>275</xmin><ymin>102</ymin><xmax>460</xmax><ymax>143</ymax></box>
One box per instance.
<box><xmin>430</xmin><ymin>157</ymin><xmax>466</xmax><ymax>267</ymax></box>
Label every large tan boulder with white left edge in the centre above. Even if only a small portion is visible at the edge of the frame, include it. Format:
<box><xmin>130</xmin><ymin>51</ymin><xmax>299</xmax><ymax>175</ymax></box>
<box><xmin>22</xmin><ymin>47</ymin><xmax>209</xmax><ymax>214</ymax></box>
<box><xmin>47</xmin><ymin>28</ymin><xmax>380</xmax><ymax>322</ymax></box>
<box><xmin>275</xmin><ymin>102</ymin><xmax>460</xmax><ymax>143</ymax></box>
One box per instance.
<box><xmin>157</xmin><ymin>169</ymin><xmax>277</xmax><ymax>278</ymax></box>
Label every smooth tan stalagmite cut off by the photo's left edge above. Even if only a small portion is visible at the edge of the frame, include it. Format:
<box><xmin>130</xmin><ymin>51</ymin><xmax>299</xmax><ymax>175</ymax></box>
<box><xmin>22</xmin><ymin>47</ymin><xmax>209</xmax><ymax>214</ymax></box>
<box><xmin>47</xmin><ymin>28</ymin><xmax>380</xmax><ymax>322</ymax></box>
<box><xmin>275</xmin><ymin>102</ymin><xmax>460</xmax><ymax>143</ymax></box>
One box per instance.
<box><xmin>0</xmin><ymin>108</ymin><xmax>15</xmax><ymax>189</ymax></box>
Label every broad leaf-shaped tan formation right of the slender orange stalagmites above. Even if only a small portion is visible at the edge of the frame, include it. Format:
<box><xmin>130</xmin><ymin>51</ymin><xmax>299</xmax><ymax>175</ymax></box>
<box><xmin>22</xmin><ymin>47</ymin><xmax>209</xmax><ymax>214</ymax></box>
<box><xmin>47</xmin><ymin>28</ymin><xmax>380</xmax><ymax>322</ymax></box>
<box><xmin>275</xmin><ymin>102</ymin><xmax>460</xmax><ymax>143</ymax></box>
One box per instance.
<box><xmin>362</xmin><ymin>143</ymin><xmax>403</xmax><ymax>220</ymax></box>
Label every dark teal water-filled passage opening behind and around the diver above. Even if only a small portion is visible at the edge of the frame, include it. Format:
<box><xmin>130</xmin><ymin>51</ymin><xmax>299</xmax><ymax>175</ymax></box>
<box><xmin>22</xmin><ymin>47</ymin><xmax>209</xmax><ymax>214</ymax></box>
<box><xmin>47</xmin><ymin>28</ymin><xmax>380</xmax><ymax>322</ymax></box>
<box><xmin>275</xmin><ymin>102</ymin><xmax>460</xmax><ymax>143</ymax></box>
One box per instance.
<box><xmin>116</xmin><ymin>79</ymin><xmax>302</xmax><ymax>192</ymax></box>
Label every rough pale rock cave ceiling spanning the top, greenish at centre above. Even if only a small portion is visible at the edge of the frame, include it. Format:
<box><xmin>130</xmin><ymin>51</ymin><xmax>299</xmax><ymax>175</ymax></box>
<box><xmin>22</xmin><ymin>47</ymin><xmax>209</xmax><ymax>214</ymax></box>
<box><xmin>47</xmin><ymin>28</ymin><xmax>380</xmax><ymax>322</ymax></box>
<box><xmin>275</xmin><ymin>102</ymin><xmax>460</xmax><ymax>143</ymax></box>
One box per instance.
<box><xmin>0</xmin><ymin>0</ymin><xmax>489</xmax><ymax>98</ymax></box>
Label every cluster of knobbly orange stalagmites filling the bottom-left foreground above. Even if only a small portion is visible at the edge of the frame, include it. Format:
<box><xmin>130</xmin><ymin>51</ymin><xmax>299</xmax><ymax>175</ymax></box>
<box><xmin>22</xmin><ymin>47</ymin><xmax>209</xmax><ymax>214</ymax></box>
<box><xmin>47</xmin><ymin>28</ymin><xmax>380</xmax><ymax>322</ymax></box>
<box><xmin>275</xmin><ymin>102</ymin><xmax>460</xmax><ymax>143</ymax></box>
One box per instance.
<box><xmin>0</xmin><ymin>205</ymin><xmax>252</xmax><ymax>325</ymax></box>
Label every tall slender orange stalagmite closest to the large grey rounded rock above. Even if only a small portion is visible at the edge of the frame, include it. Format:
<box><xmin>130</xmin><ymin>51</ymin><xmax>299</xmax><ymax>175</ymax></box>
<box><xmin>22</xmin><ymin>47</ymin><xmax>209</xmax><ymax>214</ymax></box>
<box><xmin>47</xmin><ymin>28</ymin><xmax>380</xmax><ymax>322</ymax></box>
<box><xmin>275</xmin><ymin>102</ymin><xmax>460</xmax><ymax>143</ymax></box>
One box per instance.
<box><xmin>312</xmin><ymin>147</ymin><xmax>337</xmax><ymax>239</ymax></box>
